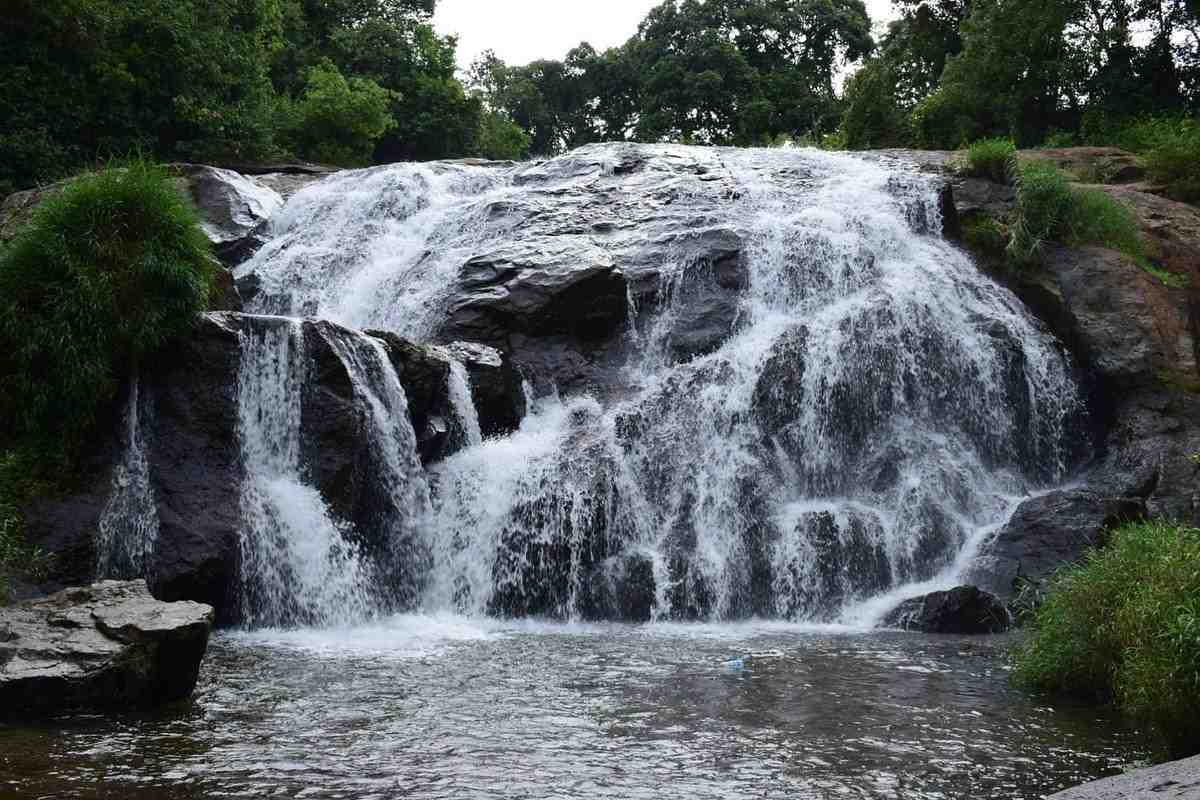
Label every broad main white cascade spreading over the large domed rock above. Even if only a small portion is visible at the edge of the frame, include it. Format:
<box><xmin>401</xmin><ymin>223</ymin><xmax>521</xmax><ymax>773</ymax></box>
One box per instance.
<box><xmin>239</xmin><ymin>146</ymin><xmax>1082</xmax><ymax>620</ymax></box>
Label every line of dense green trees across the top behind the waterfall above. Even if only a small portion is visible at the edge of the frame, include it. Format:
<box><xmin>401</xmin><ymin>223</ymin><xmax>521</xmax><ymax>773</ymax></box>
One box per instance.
<box><xmin>0</xmin><ymin>0</ymin><xmax>1200</xmax><ymax>191</ymax></box>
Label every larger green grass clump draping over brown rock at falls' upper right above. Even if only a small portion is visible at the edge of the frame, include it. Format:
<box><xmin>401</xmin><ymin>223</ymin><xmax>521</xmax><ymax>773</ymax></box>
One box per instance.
<box><xmin>1008</xmin><ymin>160</ymin><xmax>1146</xmax><ymax>266</ymax></box>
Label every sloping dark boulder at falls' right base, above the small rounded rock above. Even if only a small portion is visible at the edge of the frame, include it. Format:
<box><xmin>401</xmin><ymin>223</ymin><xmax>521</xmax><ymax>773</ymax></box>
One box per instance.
<box><xmin>965</xmin><ymin>489</ymin><xmax>1146</xmax><ymax>601</ymax></box>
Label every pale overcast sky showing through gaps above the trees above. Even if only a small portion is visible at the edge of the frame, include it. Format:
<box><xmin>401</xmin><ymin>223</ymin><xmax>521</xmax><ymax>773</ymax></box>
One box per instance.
<box><xmin>433</xmin><ymin>0</ymin><xmax>892</xmax><ymax>68</ymax></box>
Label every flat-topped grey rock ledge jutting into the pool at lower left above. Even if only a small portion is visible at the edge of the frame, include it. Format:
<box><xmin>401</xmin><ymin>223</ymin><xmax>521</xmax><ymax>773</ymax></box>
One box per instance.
<box><xmin>0</xmin><ymin>581</ymin><xmax>214</xmax><ymax>716</ymax></box>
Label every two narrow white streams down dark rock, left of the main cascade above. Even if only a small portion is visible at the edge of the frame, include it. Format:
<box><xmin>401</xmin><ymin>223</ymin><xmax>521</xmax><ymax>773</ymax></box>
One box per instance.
<box><xmin>231</xmin><ymin>318</ymin><xmax>430</xmax><ymax>626</ymax></box>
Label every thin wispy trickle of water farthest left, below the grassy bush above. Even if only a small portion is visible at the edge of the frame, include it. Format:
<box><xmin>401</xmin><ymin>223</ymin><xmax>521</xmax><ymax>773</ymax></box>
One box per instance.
<box><xmin>96</xmin><ymin>374</ymin><xmax>158</xmax><ymax>579</ymax></box>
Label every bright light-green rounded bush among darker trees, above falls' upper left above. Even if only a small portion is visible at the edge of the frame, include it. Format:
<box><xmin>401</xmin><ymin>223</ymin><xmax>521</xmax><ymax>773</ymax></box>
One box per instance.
<box><xmin>279</xmin><ymin>61</ymin><xmax>396</xmax><ymax>167</ymax></box>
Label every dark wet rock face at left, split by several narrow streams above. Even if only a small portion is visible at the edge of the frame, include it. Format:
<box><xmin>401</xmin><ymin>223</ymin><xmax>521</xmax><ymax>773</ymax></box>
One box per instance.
<box><xmin>24</xmin><ymin>313</ymin><xmax>513</xmax><ymax>622</ymax></box>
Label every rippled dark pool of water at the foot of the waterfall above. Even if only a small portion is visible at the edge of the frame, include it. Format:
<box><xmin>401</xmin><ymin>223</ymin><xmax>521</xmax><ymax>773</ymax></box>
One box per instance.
<box><xmin>0</xmin><ymin>616</ymin><xmax>1141</xmax><ymax>800</ymax></box>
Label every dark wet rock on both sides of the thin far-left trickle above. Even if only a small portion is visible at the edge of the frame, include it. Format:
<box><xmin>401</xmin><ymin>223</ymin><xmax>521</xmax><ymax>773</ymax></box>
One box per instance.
<box><xmin>24</xmin><ymin>314</ymin><xmax>241</xmax><ymax>619</ymax></box>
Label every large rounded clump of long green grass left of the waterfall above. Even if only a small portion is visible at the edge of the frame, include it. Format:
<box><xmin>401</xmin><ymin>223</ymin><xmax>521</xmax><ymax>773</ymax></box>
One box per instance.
<box><xmin>0</xmin><ymin>161</ymin><xmax>214</xmax><ymax>453</ymax></box>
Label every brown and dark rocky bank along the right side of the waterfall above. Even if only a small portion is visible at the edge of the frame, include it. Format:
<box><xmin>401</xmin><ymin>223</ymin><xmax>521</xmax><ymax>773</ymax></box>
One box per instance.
<box><xmin>887</xmin><ymin>148</ymin><xmax>1200</xmax><ymax>599</ymax></box>
